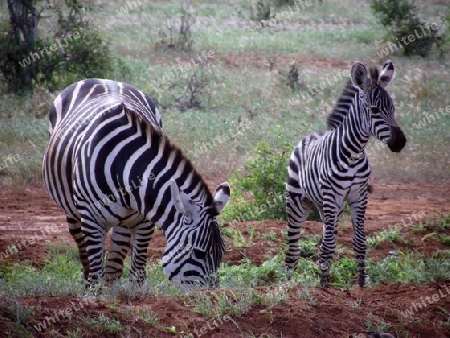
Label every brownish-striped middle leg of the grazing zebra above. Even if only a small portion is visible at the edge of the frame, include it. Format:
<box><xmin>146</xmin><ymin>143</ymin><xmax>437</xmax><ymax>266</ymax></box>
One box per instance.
<box><xmin>105</xmin><ymin>226</ymin><xmax>131</xmax><ymax>283</ymax></box>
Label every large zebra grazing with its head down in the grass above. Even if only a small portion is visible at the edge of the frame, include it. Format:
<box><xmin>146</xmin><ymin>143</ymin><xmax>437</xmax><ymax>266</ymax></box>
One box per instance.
<box><xmin>43</xmin><ymin>79</ymin><xmax>230</xmax><ymax>284</ymax></box>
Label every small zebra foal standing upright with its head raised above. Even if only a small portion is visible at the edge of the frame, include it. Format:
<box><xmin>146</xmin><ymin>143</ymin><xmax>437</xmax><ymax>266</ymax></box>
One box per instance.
<box><xmin>286</xmin><ymin>61</ymin><xmax>406</xmax><ymax>287</ymax></box>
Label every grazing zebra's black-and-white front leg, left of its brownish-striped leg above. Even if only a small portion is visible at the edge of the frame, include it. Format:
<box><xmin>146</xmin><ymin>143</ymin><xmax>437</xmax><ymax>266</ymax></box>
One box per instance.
<box><xmin>81</xmin><ymin>211</ymin><xmax>107</xmax><ymax>286</ymax></box>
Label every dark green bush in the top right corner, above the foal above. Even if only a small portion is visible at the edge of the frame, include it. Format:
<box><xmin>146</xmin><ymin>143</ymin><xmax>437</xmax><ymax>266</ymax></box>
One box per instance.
<box><xmin>371</xmin><ymin>0</ymin><xmax>438</xmax><ymax>57</ymax></box>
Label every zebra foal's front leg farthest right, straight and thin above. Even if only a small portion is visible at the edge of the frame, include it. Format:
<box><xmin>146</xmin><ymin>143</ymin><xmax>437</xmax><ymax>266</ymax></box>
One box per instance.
<box><xmin>348</xmin><ymin>185</ymin><xmax>368</xmax><ymax>287</ymax></box>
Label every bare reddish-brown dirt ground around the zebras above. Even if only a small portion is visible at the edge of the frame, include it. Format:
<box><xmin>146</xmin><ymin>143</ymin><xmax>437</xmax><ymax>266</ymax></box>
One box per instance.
<box><xmin>0</xmin><ymin>180</ymin><xmax>450</xmax><ymax>338</ymax></box>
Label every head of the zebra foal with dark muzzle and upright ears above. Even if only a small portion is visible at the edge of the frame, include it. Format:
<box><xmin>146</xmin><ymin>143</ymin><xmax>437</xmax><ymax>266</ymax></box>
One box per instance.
<box><xmin>351</xmin><ymin>60</ymin><xmax>406</xmax><ymax>152</ymax></box>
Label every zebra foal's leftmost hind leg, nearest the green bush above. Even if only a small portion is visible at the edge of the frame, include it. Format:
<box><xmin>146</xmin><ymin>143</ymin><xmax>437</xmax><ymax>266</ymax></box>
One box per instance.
<box><xmin>285</xmin><ymin>191</ymin><xmax>312</xmax><ymax>271</ymax></box>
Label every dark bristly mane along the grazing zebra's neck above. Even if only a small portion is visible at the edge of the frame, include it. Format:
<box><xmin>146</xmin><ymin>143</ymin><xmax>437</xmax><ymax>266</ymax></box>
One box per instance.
<box><xmin>123</xmin><ymin>106</ymin><xmax>214</xmax><ymax>207</ymax></box>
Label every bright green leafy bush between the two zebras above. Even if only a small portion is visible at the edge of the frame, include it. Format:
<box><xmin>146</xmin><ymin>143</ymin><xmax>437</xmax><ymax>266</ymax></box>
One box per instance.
<box><xmin>222</xmin><ymin>129</ymin><xmax>320</xmax><ymax>222</ymax></box>
